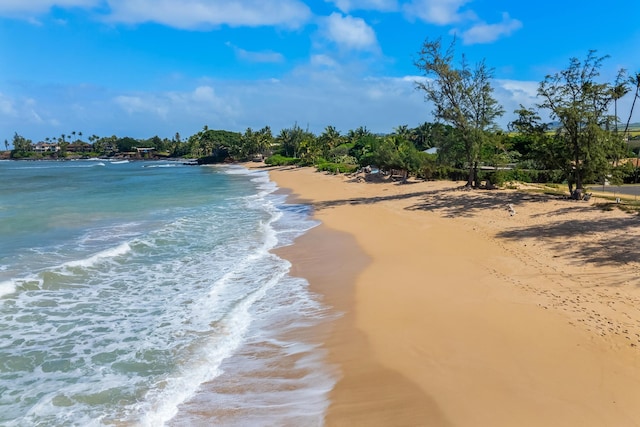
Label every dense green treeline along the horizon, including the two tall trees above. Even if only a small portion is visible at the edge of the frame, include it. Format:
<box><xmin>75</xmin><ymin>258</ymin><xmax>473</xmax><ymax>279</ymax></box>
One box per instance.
<box><xmin>5</xmin><ymin>39</ymin><xmax>640</xmax><ymax>191</ymax></box>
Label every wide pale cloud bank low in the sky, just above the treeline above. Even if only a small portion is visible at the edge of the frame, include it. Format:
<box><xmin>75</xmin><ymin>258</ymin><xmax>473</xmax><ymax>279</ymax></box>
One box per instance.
<box><xmin>6</xmin><ymin>71</ymin><xmax>640</xmax><ymax>141</ymax></box>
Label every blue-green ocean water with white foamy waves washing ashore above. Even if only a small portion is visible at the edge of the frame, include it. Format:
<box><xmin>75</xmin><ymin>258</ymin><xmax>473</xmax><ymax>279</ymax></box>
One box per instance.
<box><xmin>0</xmin><ymin>160</ymin><xmax>336</xmax><ymax>426</ymax></box>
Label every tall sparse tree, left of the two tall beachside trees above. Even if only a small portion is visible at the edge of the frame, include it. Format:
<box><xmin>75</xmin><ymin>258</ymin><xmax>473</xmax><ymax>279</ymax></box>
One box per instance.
<box><xmin>415</xmin><ymin>35</ymin><xmax>504</xmax><ymax>186</ymax></box>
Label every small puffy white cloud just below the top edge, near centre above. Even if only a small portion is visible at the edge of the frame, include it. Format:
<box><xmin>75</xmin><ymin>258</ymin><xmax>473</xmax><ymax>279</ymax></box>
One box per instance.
<box><xmin>323</xmin><ymin>13</ymin><xmax>378</xmax><ymax>51</ymax></box>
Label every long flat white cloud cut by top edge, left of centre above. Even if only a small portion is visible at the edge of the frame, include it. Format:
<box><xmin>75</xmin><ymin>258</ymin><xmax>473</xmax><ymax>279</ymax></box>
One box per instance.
<box><xmin>108</xmin><ymin>0</ymin><xmax>311</xmax><ymax>29</ymax></box>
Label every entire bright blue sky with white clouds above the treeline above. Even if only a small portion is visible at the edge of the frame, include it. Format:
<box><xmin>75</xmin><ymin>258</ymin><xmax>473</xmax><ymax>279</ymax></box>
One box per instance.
<box><xmin>0</xmin><ymin>0</ymin><xmax>640</xmax><ymax>148</ymax></box>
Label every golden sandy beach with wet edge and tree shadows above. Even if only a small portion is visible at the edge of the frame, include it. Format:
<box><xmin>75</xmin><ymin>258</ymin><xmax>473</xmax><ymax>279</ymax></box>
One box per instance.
<box><xmin>267</xmin><ymin>168</ymin><xmax>640</xmax><ymax>426</ymax></box>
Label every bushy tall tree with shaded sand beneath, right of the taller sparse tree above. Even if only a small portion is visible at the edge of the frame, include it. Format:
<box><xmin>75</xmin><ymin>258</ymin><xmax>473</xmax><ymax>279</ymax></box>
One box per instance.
<box><xmin>538</xmin><ymin>50</ymin><xmax>623</xmax><ymax>193</ymax></box>
